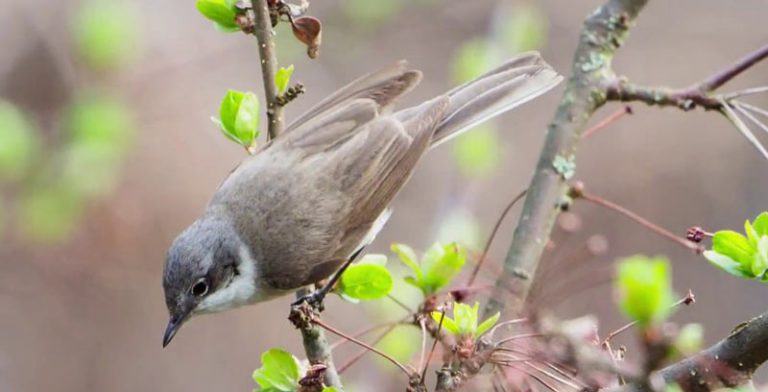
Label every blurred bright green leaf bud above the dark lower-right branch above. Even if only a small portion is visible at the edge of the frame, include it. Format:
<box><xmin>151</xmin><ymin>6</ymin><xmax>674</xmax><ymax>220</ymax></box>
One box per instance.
<box><xmin>617</xmin><ymin>256</ymin><xmax>673</xmax><ymax>326</ymax></box>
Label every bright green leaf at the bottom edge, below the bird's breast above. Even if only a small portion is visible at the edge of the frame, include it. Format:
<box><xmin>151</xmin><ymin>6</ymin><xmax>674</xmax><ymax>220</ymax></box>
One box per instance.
<box><xmin>253</xmin><ymin>348</ymin><xmax>300</xmax><ymax>392</ymax></box>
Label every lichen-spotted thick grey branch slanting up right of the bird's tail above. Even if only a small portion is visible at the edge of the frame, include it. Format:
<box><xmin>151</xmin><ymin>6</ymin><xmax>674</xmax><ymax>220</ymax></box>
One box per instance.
<box><xmin>486</xmin><ymin>0</ymin><xmax>647</xmax><ymax>314</ymax></box>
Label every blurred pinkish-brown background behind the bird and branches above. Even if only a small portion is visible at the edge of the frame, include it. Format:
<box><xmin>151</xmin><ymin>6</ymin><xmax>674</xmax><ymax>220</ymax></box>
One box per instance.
<box><xmin>0</xmin><ymin>0</ymin><xmax>768</xmax><ymax>392</ymax></box>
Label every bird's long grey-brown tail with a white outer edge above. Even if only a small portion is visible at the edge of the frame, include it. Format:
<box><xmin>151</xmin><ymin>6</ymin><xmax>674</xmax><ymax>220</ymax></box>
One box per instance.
<box><xmin>395</xmin><ymin>52</ymin><xmax>563</xmax><ymax>147</ymax></box>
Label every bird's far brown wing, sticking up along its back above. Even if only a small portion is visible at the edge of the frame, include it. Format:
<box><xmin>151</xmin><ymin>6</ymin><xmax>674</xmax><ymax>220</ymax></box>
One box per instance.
<box><xmin>284</xmin><ymin>61</ymin><xmax>421</xmax><ymax>133</ymax></box>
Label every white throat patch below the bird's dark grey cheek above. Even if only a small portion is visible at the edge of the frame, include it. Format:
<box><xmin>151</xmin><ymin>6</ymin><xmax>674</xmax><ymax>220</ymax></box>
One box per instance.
<box><xmin>195</xmin><ymin>246</ymin><xmax>260</xmax><ymax>313</ymax></box>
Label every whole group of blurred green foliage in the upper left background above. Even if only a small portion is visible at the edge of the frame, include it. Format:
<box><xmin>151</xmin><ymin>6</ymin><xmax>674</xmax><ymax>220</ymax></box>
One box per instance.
<box><xmin>0</xmin><ymin>1</ymin><xmax>139</xmax><ymax>243</ymax></box>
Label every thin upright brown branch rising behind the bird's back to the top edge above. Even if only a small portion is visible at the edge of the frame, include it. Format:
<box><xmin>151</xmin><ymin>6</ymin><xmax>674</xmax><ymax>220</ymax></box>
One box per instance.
<box><xmin>253</xmin><ymin>0</ymin><xmax>285</xmax><ymax>139</ymax></box>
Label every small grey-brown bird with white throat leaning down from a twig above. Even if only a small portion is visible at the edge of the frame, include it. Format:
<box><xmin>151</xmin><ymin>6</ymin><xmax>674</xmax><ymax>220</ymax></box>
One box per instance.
<box><xmin>163</xmin><ymin>53</ymin><xmax>562</xmax><ymax>347</ymax></box>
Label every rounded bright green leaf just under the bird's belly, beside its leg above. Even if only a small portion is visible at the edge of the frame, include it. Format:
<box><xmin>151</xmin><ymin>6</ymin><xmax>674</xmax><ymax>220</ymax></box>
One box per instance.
<box><xmin>340</xmin><ymin>263</ymin><xmax>392</xmax><ymax>300</ymax></box>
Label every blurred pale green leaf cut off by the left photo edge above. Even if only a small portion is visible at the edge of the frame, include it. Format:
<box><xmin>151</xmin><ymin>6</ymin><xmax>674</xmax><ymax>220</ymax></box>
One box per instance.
<box><xmin>0</xmin><ymin>100</ymin><xmax>38</xmax><ymax>181</ymax></box>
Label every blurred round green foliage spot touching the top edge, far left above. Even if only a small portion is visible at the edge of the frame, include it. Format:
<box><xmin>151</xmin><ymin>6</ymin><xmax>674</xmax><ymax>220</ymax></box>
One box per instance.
<box><xmin>73</xmin><ymin>0</ymin><xmax>141</xmax><ymax>69</ymax></box>
